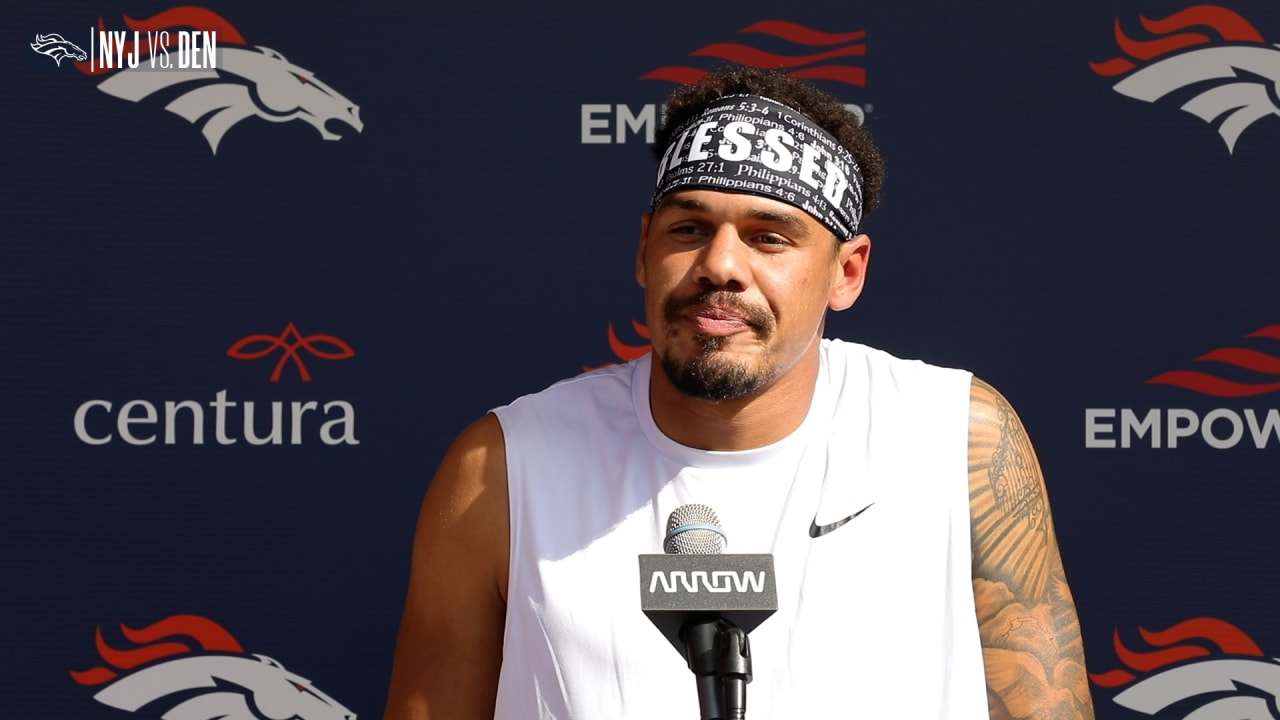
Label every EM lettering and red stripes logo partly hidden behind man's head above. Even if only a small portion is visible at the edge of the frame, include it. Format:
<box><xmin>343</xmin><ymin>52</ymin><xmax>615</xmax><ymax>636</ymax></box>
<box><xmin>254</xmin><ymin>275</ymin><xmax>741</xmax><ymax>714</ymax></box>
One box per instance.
<box><xmin>581</xmin><ymin>20</ymin><xmax>870</xmax><ymax>145</ymax></box>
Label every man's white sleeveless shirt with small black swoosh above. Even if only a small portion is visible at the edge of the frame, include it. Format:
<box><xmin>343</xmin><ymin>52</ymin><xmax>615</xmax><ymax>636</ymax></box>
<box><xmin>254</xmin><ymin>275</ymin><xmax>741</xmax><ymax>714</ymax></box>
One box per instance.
<box><xmin>494</xmin><ymin>341</ymin><xmax>988</xmax><ymax>720</ymax></box>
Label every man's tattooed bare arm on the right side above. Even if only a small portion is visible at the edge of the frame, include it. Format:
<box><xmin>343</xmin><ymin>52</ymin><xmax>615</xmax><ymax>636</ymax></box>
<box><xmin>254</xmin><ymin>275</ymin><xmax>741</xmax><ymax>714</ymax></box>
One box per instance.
<box><xmin>969</xmin><ymin>378</ymin><xmax>1093</xmax><ymax>720</ymax></box>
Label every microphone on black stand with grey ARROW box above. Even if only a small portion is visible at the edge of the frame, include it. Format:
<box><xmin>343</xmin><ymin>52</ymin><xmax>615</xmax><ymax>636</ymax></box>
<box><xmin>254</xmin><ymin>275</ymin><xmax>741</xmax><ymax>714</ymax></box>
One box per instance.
<box><xmin>640</xmin><ymin>503</ymin><xmax>778</xmax><ymax>720</ymax></box>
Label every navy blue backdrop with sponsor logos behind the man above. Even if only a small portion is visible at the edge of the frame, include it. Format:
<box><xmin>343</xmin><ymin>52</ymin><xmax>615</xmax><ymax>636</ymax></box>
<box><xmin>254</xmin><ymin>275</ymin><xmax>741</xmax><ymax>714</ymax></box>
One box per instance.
<box><xmin>0</xmin><ymin>0</ymin><xmax>1280</xmax><ymax>719</ymax></box>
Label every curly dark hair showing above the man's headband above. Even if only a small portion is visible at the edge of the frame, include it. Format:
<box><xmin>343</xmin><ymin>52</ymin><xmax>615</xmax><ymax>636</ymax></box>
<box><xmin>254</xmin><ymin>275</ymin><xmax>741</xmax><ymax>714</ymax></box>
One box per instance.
<box><xmin>653</xmin><ymin>67</ymin><xmax>884</xmax><ymax>222</ymax></box>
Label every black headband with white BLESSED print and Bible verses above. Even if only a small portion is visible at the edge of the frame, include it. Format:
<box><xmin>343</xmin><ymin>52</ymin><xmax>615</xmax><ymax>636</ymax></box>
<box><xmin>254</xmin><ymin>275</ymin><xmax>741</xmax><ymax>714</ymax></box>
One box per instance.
<box><xmin>650</xmin><ymin>95</ymin><xmax>863</xmax><ymax>241</ymax></box>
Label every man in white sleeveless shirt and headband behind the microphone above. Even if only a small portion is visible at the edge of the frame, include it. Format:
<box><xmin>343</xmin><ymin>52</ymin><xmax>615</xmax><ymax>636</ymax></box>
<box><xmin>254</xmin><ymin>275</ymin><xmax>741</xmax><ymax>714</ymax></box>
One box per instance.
<box><xmin>387</xmin><ymin>69</ymin><xmax>1093</xmax><ymax>720</ymax></box>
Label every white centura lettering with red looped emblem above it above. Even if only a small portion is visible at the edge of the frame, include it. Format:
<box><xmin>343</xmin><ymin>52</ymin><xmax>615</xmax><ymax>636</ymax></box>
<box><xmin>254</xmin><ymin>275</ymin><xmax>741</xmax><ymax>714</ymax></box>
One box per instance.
<box><xmin>73</xmin><ymin>323</ymin><xmax>360</xmax><ymax>446</ymax></box>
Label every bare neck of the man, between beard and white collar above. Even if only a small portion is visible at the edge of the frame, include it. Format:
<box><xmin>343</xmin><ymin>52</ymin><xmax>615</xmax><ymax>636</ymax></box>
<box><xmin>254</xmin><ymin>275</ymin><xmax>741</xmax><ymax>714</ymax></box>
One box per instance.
<box><xmin>649</xmin><ymin>348</ymin><xmax>820</xmax><ymax>451</ymax></box>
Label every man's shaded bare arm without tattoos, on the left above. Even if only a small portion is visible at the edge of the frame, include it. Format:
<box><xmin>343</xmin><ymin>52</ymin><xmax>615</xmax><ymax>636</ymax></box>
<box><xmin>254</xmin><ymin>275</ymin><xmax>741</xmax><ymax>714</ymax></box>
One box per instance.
<box><xmin>384</xmin><ymin>415</ymin><xmax>511</xmax><ymax>720</ymax></box>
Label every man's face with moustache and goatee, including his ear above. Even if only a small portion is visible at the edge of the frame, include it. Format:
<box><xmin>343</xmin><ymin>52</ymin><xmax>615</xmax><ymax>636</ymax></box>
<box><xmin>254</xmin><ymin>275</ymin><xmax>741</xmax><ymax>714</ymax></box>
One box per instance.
<box><xmin>636</xmin><ymin>190</ymin><xmax>870</xmax><ymax>401</ymax></box>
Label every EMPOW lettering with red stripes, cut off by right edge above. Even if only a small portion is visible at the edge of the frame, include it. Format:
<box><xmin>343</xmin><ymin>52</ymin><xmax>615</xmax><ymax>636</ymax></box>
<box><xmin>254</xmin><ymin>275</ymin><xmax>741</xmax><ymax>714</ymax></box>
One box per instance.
<box><xmin>1084</xmin><ymin>325</ymin><xmax>1280</xmax><ymax>450</ymax></box>
